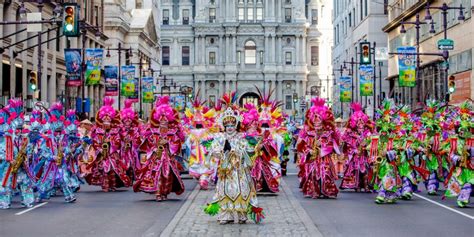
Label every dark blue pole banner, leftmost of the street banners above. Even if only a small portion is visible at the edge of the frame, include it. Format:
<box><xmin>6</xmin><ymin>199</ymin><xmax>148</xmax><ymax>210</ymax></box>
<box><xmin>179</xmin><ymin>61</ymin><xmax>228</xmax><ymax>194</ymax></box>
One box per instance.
<box><xmin>64</xmin><ymin>49</ymin><xmax>82</xmax><ymax>86</ymax></box>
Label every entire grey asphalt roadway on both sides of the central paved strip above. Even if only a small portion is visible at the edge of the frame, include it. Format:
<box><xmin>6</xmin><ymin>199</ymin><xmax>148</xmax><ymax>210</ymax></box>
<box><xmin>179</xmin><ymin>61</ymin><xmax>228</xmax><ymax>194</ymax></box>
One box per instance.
<box><xmin>0</xmin><ymin>161</ymin><xmax>474</xmax><ymax>237</ymax></box>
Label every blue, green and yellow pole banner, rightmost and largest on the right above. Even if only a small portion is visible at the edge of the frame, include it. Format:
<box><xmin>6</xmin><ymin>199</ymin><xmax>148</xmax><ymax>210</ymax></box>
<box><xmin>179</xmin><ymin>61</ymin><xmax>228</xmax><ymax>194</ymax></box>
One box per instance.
<box><xmin>397</xmin><ymin>46</ymin><xmax>416</xmax><ymax>87</ymax></box>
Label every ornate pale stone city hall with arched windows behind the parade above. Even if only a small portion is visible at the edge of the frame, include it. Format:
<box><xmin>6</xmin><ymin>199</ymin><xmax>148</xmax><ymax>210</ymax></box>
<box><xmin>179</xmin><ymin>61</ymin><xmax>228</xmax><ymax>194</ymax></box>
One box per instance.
<box><xmin>159</xmin><ymin>0</ymin><xmax>333</xmax><ymax>117</ymax></box>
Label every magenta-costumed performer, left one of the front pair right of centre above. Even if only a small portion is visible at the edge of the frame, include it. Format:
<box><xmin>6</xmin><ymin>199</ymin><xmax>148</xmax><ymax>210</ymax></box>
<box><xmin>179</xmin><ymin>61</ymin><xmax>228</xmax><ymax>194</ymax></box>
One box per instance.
<box><xmin>297</xmin><ymin>98</ymin><xmax>340</xmax><ymax>198</ymax></box>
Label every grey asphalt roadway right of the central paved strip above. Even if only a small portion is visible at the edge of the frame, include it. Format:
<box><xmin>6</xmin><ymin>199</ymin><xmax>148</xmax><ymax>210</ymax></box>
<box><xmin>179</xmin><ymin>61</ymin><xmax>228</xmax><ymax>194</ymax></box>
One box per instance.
<box><xmin>284</xmin><ymin>161</ymin><xmax>474</xmax><ymax>237</ymax></box>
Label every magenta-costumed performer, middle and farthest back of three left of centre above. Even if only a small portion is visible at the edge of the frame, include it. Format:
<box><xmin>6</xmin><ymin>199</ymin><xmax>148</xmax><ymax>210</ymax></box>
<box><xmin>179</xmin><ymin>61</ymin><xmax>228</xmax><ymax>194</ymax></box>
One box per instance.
<box><xmin>120</xmin><ymin>99</ymin><xmax>141</xmax><ymax>173</ymax></box>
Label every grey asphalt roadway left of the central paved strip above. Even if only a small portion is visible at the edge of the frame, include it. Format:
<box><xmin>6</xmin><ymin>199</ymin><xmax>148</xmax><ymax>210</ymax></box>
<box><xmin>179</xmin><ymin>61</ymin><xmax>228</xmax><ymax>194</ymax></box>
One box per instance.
<box><xmin>0</xmin><ymin>179</ymin><xmax>196</xmax><ymax>237</ymax></box>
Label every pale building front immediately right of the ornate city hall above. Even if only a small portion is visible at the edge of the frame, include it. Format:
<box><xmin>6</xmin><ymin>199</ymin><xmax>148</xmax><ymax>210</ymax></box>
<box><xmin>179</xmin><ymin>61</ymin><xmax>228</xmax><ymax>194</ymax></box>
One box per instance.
<box><xmin>332</xmin><ymin>0</ymin><xmax>388</xmax><ymax>118</ymax></box>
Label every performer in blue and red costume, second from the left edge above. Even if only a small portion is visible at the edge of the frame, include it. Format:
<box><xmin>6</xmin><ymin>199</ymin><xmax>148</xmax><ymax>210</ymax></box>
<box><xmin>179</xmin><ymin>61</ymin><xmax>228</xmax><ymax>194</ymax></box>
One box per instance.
<box><xmin>37</xmin><ymin>103</ymin><xmax>76</xmax><ymax>203</ymax></box>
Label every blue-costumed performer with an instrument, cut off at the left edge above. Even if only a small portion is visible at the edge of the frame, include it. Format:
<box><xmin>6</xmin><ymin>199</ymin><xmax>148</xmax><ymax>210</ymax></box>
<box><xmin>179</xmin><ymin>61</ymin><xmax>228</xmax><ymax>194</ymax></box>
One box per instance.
<box><xmin>0</xmin><ymin>99</ymin><xmax>34</xmax><ymax>209</ymax></box>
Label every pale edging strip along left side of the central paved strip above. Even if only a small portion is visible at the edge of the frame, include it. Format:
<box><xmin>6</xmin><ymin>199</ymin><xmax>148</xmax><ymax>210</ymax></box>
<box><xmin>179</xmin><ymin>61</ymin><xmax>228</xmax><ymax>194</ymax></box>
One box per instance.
<box><xmin>142</xmin><ymin>184</ymin><xmax>200</xmax><ymax>237</ymax></box>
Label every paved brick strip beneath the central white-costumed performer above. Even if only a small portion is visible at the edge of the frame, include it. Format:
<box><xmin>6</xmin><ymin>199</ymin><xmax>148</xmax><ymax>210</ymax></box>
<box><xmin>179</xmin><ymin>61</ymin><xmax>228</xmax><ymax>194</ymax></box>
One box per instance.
<box><xmin>155</xmin><ymin>180</ymin><xmax>322</xmax><ymax>237</ymax></box>
